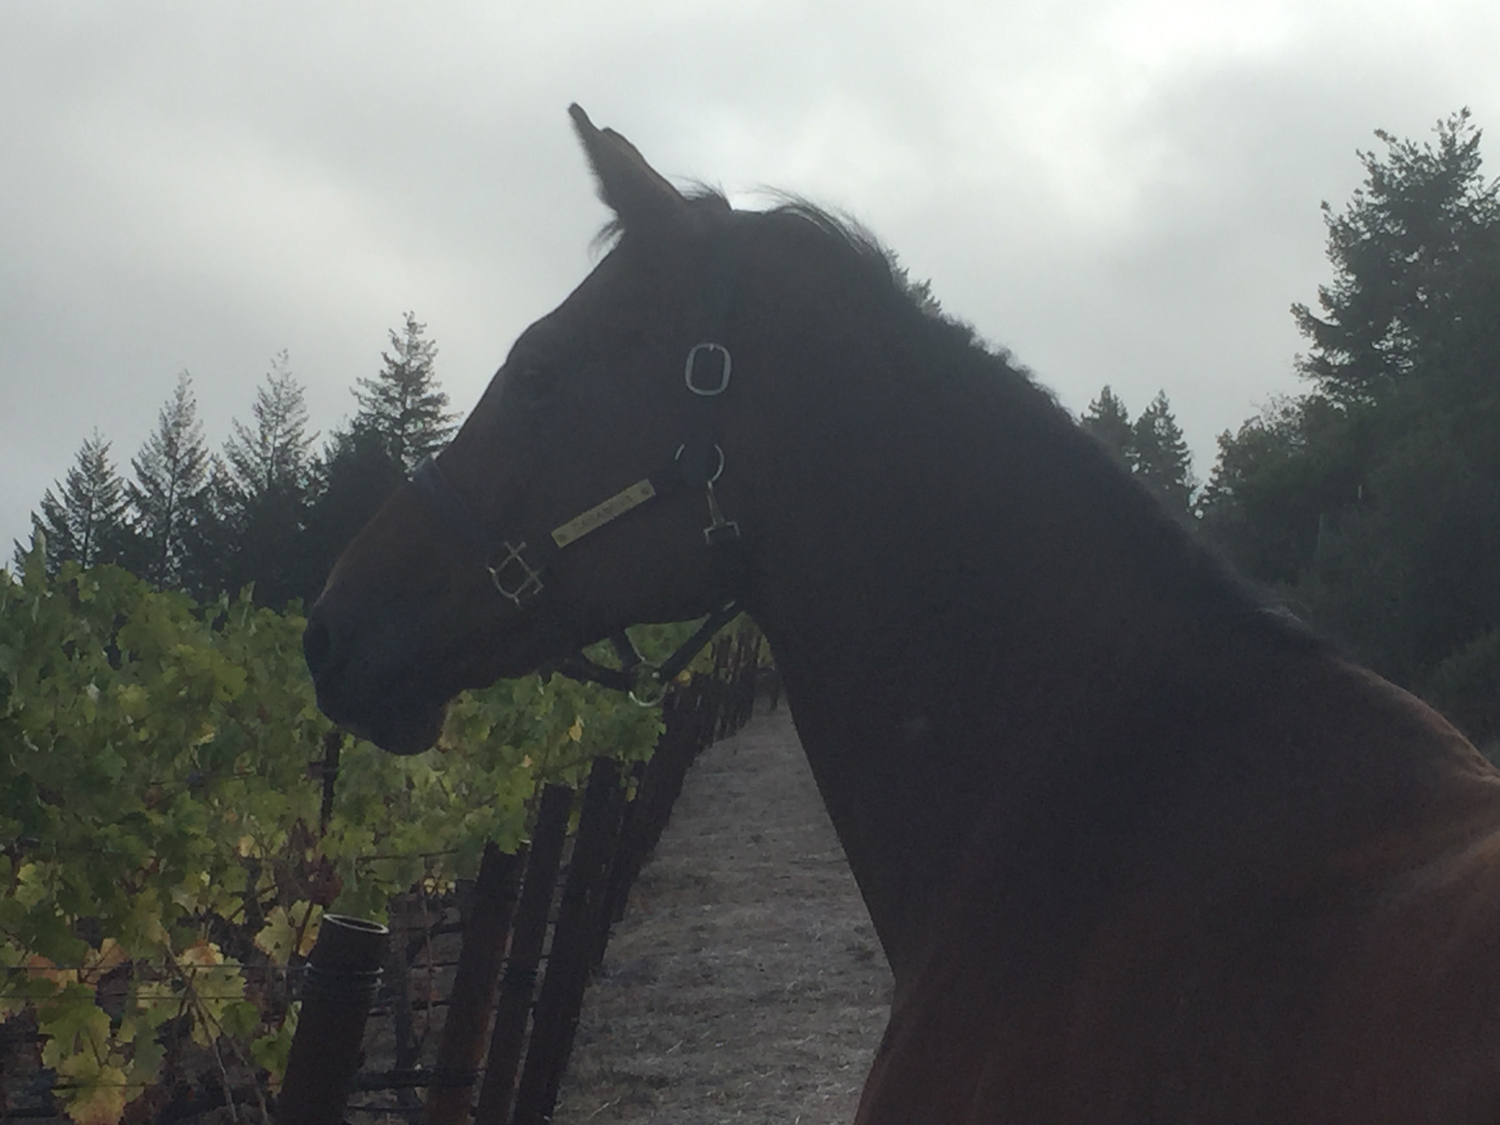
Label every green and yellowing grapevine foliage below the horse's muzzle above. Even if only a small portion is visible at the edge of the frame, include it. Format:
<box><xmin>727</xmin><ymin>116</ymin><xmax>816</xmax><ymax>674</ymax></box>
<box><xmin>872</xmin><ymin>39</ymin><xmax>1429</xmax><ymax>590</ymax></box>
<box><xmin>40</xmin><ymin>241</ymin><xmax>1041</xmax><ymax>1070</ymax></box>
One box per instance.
<box><xmin>0</xmin><ymin>548</ymin><xmax>758</xmax><ymax>1125</ymax></box>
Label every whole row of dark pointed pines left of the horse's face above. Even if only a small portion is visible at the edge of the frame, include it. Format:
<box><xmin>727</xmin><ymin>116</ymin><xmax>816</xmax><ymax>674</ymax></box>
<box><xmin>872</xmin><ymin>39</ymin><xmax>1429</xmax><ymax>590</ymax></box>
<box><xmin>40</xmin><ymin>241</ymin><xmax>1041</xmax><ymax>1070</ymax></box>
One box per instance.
<box><xmin>17</xmin><ymin>314</ymin><xmax>455</xmax><ymax>609</ymax></box>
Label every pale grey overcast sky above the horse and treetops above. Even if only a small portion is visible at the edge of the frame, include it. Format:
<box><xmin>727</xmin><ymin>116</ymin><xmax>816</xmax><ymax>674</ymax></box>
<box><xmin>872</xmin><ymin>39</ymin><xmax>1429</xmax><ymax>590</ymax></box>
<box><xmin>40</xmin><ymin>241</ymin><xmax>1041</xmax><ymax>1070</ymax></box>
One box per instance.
<box><xmin>0</xmin><ymin>0</ymin><xmax>1500</xmax><ymax>563</ymax></box>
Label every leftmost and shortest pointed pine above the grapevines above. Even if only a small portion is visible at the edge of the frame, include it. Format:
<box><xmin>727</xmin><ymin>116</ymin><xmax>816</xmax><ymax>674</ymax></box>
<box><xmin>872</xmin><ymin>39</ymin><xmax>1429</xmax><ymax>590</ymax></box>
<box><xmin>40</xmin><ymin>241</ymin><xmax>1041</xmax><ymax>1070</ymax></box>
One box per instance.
<box><xmin>17</xmin><ymin>429</ymin><xmax>131</xmax><ymax>572</ymax></box>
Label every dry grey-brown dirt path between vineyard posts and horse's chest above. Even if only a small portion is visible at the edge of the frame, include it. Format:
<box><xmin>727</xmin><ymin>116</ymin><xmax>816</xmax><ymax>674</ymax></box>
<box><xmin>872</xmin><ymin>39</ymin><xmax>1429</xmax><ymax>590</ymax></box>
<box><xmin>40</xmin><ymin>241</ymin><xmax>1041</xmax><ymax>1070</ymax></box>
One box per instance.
<box><xmin>554</xmin><ymin>711</ymin><xmax>891</xmax><ymax>1125</ymax></box>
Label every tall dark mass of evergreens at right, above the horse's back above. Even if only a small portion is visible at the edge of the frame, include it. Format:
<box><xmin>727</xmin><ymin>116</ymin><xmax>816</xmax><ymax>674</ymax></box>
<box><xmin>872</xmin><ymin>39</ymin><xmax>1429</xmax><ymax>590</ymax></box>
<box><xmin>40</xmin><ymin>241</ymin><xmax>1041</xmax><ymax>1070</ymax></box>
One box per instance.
<box><xmin>1199</xmin><ymin>111</ymin><xmax>1500</xmax><ymax>753</ymax></box>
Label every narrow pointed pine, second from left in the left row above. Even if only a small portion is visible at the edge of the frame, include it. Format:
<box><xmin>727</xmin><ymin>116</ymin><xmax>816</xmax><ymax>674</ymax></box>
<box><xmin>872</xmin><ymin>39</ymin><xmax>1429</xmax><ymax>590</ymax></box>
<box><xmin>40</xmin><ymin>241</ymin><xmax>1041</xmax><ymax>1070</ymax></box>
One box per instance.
<box><xmin>126</xmin><ymin>372</ymin><xmax>210</xmax><ymax>587</ymax></box>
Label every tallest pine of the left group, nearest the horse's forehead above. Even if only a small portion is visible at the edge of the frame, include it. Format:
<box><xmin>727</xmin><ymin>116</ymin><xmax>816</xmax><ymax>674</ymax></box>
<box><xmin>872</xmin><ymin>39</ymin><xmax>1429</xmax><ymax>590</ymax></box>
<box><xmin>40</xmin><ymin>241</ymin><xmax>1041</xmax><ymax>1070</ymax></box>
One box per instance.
<box><xmin>351</xmin><ymin>312</ymin><xmax>456</xmax><ymax>473</ymax></box>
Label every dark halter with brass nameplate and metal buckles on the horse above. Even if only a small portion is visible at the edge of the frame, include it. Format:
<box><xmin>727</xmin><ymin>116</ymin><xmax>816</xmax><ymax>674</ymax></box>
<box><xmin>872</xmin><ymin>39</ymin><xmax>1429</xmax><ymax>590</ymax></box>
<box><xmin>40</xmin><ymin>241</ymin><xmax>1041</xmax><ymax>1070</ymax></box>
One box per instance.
<box><xmin>411</xmin><ymin>227</ymin><xmax>740</xmax><ymax>704</ymax></box>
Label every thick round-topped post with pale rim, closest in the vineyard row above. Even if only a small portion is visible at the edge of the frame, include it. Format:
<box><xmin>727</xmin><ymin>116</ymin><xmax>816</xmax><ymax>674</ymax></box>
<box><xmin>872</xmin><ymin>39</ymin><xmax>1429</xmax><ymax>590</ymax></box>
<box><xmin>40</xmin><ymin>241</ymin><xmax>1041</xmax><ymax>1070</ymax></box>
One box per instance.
<box><xmin>276</xmin><ymin>914</ymin><xmax>390</xmax><ymax>1125</ymax></box>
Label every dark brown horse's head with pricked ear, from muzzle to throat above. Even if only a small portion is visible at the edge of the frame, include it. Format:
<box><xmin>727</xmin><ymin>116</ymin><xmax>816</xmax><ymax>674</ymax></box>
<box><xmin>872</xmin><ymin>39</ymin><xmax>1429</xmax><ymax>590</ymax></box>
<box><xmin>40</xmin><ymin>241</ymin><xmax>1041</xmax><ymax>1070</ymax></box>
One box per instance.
<box><xmin>305</xmin><ymin>107</ymin><xmax>774</xmax><ymax>753</ymax></box>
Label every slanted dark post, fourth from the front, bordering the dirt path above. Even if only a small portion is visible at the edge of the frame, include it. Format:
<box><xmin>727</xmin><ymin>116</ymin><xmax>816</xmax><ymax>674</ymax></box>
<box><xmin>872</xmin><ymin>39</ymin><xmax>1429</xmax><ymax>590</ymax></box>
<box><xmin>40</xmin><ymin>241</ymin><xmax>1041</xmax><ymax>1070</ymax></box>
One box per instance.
<box><xmin>513</xmin><ymin>758</ymin><xmax>624</xmax><ymax>1125</ymax></box>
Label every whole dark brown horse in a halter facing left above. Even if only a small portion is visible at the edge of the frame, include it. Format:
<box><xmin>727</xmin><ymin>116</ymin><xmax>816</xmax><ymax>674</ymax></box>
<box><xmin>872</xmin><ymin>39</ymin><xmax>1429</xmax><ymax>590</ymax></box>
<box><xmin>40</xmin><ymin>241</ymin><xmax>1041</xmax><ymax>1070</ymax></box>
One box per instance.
<box><xmin>305</xmin><ymin>107</ymin><xmax>1500</xmax><ymax>1125</ymax></box>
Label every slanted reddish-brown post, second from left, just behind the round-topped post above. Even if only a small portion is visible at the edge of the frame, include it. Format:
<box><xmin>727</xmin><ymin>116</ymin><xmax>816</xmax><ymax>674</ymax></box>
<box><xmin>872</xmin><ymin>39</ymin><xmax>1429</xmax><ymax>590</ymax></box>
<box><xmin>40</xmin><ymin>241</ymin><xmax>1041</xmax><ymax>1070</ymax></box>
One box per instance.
<box><xmin>426</xmin><ymin>843</ymin><xmax>522</xmax><ymax>1125</ymax></box>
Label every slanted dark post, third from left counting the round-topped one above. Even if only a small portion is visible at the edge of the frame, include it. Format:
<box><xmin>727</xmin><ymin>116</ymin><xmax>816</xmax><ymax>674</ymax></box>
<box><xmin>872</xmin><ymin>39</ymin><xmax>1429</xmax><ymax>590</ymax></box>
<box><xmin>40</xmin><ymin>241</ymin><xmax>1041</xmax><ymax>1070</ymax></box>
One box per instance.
<box><xmin>474</xmin><ymin>785</ymin><xmax>573</xmax><ymax>1125</ymax></box>
